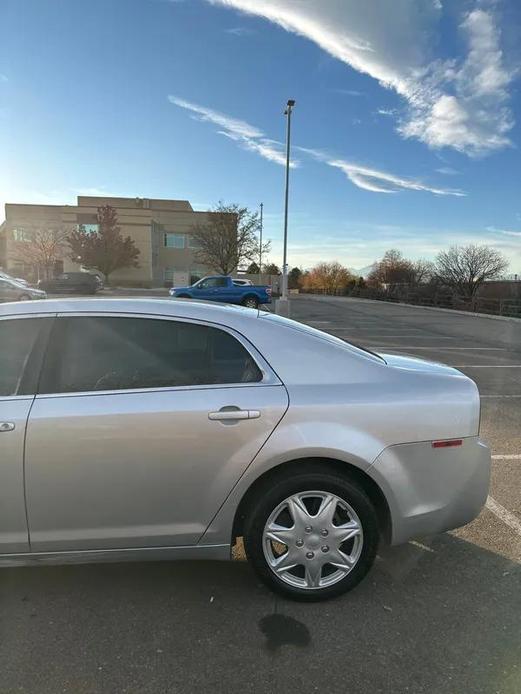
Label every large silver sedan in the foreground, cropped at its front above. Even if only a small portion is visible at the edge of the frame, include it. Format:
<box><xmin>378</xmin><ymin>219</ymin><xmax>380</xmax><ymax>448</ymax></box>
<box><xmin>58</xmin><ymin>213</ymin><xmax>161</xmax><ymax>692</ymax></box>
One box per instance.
<box><xmin>0</xmin><ymin>299</ymin><xmax>490</xmax><ymax>600</ymax></box>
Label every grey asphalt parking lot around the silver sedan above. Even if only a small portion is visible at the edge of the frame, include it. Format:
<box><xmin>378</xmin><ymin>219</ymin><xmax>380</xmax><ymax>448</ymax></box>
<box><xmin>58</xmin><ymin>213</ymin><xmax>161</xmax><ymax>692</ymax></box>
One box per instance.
<box><xmin>0</xmin><ymin>297</ymin><xmax>521</xmax><ymax>694</ymax></box>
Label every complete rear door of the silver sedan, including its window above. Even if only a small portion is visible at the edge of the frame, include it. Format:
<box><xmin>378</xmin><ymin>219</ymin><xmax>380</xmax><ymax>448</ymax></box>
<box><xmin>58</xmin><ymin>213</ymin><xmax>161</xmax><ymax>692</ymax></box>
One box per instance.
<box><xmin>26</xmin><ymin>315</ymin><xmax>288</xmax><ymax>551</ymax></box>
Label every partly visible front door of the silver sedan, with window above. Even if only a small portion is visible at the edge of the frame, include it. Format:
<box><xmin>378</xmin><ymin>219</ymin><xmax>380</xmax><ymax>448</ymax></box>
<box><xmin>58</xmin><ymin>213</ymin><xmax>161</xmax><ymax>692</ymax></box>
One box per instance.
<box><xmin>0</xmin><ymin>317</ymin><xmax>49</xmax><ymax>554</ymax></box>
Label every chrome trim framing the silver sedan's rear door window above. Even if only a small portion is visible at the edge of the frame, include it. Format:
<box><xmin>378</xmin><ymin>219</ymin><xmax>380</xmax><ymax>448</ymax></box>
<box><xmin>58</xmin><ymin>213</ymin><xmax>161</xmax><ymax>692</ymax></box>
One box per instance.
<box><xmin>35</xmin><ymin>311</ymin><xmax>283</xmax><ymax>400</ymax></box>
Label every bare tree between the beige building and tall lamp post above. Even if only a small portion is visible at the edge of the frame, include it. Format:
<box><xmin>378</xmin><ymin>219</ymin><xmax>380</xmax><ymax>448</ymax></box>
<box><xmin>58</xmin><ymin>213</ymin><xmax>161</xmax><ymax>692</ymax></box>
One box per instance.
<box><xmin>190</xmin><ymin>202</ymin><xmax>271</xmax><ymax>275</ymax></box>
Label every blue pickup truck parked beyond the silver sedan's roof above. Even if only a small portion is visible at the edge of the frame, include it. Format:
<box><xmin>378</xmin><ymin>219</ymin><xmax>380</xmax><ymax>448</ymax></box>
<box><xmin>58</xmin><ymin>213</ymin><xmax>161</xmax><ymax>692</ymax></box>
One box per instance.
<box><xmin>169</xmin><ymin>275</ymin><xmax>271</xmax><ymax>308</ymax></box>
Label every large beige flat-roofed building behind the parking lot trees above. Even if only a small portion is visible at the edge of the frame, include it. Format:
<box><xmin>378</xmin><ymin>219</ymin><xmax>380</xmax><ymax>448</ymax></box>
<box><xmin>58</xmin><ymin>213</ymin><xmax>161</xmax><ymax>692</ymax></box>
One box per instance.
<box><xmin>0</xmin><ymin>195</ymin><xmax>230</xmax><ymax>287</ymax></box>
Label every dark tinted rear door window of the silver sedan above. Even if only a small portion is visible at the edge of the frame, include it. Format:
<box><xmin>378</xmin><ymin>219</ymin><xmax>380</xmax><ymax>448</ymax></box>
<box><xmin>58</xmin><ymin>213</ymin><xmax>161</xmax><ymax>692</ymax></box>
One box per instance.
<box><xmin>39</xmin><ymin>316</ymin><xmax>262</xmax><ymax>393</ymax></box>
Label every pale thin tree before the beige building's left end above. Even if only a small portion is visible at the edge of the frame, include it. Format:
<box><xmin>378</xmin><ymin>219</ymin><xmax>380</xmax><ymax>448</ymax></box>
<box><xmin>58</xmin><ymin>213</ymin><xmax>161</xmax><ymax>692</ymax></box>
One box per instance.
<box><xmin>13</xmin><ymin>228</ymin><xmax>69</xmax><ymax>279</ymax></box>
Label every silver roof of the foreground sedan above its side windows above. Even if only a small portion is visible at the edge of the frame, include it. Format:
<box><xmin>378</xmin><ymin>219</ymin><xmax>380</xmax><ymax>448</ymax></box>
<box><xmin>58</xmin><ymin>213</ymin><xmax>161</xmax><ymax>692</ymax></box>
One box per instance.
<box><xmin>0</xmin><ymin>297</ymin><xmax>259</xmax><ymax>326</ymax></box>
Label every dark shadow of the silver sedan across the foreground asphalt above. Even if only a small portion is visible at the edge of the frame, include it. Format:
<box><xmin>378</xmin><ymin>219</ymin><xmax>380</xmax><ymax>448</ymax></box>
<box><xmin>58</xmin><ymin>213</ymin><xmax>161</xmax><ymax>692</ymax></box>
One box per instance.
<box><xmin>0</xmin><ymin>534</ymin><xmax>521</xmax><ymax>694</ymax></box>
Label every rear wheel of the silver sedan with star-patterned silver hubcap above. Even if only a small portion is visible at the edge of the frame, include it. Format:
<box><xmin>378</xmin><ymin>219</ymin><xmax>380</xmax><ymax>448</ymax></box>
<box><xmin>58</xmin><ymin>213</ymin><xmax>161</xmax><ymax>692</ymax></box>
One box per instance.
<box><xmin>244</xmin><ymin>463</ymin><xmax>379</xmax><ymax>602</ymax></box>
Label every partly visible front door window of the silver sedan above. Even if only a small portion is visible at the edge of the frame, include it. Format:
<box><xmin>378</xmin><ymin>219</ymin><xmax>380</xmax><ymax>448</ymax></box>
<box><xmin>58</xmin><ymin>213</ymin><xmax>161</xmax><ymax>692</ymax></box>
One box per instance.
<box><xmin>0</xmin><ymin>318</ymin><xmax>42</xmax><ymax>397</ymax></box>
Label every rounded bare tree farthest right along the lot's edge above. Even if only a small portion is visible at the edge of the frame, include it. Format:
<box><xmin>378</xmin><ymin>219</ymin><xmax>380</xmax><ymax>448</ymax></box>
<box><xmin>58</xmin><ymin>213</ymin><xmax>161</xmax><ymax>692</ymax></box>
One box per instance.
<box><xmin>436</xmin><ymin>244</ymin><xmax>508</xmax><ymax>299</ymax></box>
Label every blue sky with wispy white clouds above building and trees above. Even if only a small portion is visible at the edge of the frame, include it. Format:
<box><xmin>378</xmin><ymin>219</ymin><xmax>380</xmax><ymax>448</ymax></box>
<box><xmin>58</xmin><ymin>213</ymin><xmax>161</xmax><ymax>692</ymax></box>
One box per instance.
<box><xmin>0</xmin><ymin>0</ymin><xmax>521</xmax><ymax>272</ymax></box>
